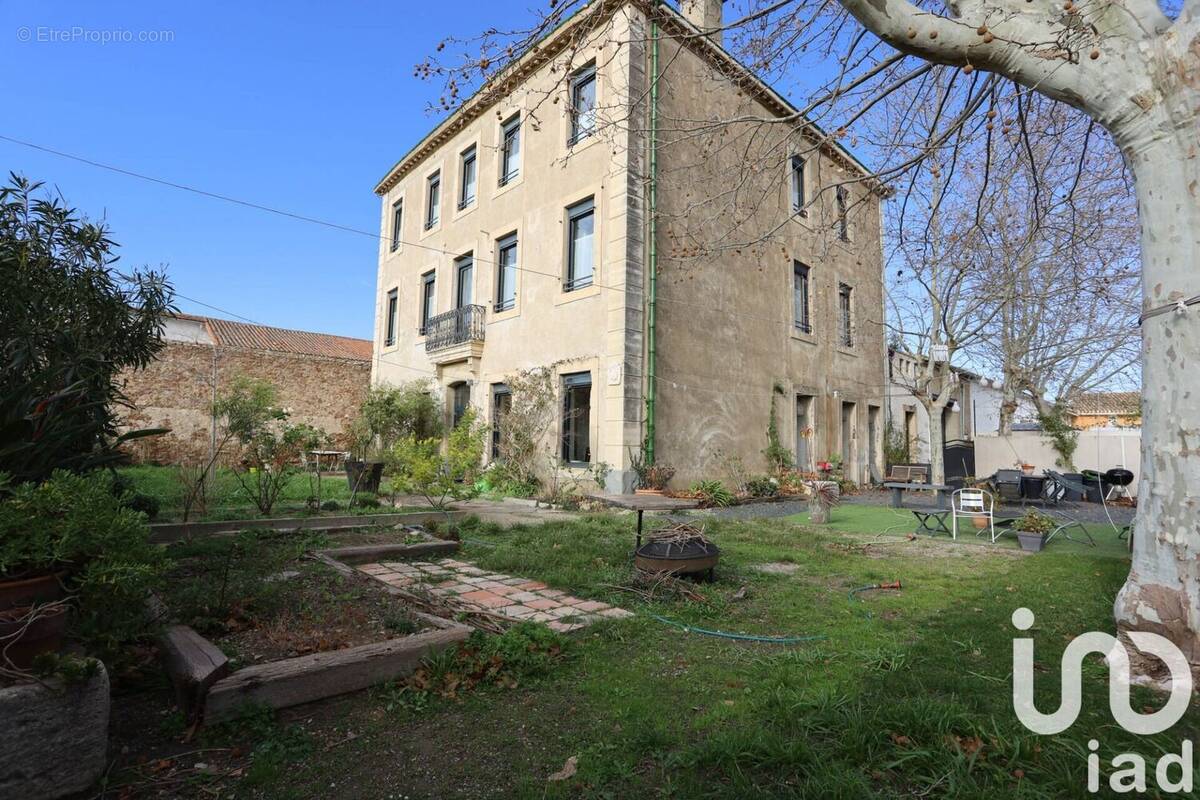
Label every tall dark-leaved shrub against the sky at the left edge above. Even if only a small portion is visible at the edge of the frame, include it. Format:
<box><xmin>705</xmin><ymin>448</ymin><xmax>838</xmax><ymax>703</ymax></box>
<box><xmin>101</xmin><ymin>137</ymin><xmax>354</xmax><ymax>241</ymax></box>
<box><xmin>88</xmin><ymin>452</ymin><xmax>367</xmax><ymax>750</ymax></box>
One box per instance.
<box><xmin>0</xmin><ymin>175</ymin><xmax>172</xmax><ymax>483</ymax></box>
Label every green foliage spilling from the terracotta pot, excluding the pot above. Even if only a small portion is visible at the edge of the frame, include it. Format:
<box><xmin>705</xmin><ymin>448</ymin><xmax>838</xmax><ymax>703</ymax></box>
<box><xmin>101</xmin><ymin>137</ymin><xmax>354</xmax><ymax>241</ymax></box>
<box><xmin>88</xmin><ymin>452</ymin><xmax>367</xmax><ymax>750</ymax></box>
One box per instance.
<box><xmin>0</xmin><ymin>470</ymin><xmax>168</xmax><ymax>657</ymax></box>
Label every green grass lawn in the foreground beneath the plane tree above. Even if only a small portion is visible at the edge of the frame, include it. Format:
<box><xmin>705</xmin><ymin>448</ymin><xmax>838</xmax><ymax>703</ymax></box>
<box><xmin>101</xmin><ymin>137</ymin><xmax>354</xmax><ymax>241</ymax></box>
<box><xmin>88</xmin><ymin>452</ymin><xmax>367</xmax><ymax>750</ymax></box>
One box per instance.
<box><xmin>142</xmin><ymin>506</ymin><xmax>1200</xmax><ymax>799</ymax></box>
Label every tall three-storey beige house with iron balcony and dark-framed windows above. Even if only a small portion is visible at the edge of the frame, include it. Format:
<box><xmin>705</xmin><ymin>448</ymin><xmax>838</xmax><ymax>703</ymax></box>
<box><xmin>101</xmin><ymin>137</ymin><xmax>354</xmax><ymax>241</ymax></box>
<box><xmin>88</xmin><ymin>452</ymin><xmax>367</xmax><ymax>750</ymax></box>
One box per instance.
<box><xmin>372</xmin><ymin>0</ymin><xmax>887</xmax><ymax>491</ymax></box>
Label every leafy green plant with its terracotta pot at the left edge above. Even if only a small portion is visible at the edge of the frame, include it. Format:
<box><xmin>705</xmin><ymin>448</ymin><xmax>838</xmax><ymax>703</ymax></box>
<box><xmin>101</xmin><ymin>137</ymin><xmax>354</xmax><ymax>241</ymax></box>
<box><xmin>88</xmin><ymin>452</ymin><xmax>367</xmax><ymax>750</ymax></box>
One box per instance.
<box><xmin>0</xmin><ymin>471</ymin><xmax>164</xmax><ymax>669</ymax></box>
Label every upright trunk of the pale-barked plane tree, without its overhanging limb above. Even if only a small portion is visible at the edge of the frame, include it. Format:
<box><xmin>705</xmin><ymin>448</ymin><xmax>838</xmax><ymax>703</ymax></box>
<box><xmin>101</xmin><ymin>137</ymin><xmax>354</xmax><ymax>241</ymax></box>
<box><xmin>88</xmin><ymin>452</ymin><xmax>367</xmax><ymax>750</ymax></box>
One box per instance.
<box><xmin>1115</xmin><ymin>113</ymin><xmax>1200</xmax><ymax>673</ymax></box>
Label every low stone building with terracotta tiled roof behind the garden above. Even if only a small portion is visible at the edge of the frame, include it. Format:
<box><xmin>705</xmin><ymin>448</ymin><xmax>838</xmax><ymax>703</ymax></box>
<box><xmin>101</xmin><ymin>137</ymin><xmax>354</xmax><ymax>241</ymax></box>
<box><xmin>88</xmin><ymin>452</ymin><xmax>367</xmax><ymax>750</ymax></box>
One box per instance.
<box><xmin>122</xmin><ymin>314</ymin><xmax>371</xmax><ymax>464</ymax></box>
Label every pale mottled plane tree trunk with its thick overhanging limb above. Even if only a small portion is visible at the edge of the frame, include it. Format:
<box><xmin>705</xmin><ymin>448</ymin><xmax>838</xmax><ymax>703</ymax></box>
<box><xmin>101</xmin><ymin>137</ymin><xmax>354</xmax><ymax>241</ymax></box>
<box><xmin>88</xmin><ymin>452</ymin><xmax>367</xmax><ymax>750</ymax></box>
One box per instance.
<box><xmin>839</xmin><ymin>0</ymin><xmax>1200</xmax><ymax>673</ymax></box>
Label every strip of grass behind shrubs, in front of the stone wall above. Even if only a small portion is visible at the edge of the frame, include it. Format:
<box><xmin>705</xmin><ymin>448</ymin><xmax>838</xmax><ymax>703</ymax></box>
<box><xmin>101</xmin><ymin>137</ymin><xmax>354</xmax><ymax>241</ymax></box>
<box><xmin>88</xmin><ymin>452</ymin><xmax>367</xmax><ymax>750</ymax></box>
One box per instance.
<box><xmin>116</xmin><ymin>464</ymin><xmax>408</xmax><ymax>522</ymax></box>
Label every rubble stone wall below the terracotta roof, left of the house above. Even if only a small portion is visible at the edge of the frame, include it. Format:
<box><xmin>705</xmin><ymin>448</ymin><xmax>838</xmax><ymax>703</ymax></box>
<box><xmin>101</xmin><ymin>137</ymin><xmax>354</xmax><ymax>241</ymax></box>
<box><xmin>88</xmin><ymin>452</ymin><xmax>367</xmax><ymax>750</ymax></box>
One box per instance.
<box><xmin>122</xmin><ymin>343</ymin><xmax>371</xmax><ymax>464</ymax></box>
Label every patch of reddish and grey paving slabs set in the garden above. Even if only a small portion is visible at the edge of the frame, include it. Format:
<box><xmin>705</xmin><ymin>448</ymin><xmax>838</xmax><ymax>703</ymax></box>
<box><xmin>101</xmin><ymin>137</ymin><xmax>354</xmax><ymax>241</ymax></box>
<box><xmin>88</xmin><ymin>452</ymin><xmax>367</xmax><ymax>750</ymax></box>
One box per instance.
<box><xmin>358</xmin><ymin>559</ymin><xmax>632</xmax><ymax>633</ymax></box>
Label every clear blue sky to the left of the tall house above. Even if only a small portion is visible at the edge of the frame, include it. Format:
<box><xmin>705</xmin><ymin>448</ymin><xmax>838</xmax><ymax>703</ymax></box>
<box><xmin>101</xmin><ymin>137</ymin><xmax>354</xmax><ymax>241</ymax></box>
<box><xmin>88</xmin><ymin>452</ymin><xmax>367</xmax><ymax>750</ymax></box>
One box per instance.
<box><xmin>0</xmin><ymin>0</ymin><xmax>528</xmax><ymax>338</ymax></box>
